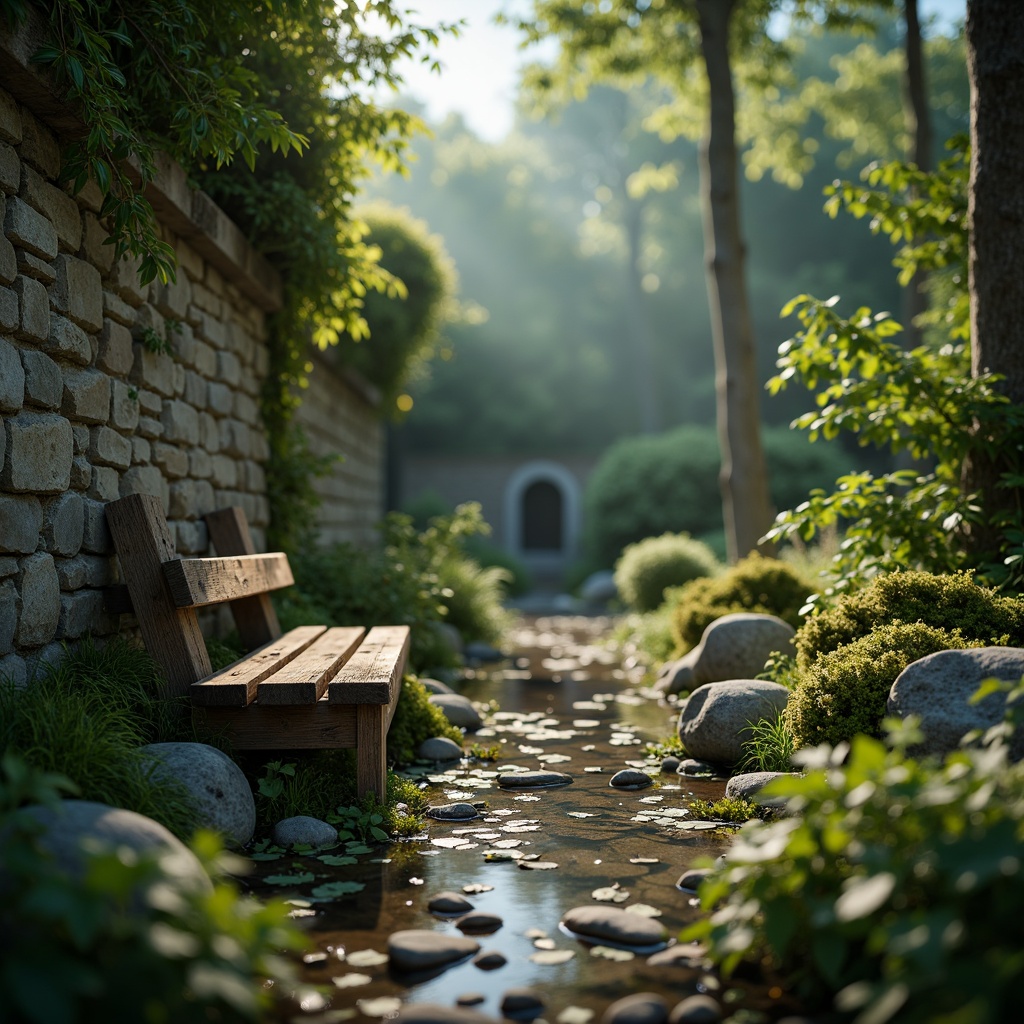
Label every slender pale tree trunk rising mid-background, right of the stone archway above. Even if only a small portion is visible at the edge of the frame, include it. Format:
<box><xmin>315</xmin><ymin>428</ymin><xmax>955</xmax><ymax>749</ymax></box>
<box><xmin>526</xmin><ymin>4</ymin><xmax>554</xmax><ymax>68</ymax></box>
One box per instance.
<box><xmin>696</xmin><ymin>0</ymin><xmax>773</xmax><ymax>562</ymax></box>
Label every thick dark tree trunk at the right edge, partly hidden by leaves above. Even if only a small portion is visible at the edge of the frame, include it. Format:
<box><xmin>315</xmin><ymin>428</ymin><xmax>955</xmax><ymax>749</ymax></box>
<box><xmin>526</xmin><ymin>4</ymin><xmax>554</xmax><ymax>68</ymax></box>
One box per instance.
<box><xmin>964</xmin><ymin>0</ymin><xmax>1024</xmax><ymax>555</ymax></box>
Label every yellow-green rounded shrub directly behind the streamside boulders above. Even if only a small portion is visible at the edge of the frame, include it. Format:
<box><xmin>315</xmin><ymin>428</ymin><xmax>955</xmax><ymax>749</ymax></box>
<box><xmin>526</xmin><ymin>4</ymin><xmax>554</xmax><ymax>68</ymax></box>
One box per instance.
<box><xmin>672</xmin><ymin>552</ymin><xmax>814</xmax><ymax>652</ymax></box>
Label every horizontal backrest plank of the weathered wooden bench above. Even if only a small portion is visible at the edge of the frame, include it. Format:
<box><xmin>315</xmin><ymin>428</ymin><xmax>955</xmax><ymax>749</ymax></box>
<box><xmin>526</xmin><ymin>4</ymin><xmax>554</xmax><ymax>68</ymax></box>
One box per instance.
<box><xmin>164</xmin><ymin>551</ymin><xmax>295</xmax><ymax>608</ymax></box>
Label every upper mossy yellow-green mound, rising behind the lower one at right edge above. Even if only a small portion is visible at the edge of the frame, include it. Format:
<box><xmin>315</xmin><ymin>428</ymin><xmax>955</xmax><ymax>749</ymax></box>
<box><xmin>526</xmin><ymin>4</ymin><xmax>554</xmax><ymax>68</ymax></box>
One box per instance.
<box><xmin>795</xmin><ymin>571</ymin><xmax>1024</xmax><ymax>670</ymax></box>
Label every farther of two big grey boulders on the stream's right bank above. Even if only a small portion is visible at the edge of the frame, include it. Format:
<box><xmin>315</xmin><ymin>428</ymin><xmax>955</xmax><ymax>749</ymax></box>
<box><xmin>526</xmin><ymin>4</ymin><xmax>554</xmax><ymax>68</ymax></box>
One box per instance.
<box><xmin>655</xmin><ymin>611</ymin><xmax>796</xmax><ymax>693</ymax></box>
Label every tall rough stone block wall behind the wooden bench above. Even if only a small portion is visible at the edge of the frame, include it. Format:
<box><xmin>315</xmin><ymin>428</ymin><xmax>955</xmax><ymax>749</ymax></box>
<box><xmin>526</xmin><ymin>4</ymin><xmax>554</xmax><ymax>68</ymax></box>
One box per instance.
<box><xmin>0</xmin><ymin>26</ymin><xmax>383</xmax><ymax>684</ymax></box>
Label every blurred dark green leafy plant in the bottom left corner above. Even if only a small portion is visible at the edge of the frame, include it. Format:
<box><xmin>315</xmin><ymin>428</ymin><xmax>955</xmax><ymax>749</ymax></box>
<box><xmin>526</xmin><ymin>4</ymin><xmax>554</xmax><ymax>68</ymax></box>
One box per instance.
<box><xmin>0</xmin><ymin>753</ymin><xmax>306</xmax><ymax>1024</ymax></box>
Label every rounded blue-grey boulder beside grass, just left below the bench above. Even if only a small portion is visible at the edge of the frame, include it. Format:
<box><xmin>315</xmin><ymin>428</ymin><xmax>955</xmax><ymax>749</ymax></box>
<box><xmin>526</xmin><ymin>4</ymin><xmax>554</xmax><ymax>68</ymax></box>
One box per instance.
<box><xmin>141</xmin><ymin>743</ymin><xmax>256</xmax><ymax>847</ymax></box>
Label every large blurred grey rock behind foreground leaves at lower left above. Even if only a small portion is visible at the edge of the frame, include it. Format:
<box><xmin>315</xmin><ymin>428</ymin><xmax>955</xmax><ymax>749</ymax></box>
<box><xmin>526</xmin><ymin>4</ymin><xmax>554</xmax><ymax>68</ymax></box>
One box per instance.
<box><xmin>8</xmin><ymin>800</ymin><xmax>213</xmax><ymax>892</ymax></box>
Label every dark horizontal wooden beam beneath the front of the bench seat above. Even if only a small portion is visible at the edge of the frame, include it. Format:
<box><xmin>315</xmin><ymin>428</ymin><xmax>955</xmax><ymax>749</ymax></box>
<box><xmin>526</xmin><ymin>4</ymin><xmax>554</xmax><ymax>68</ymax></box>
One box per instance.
<box><xmin>193</xmin><ymin>697</ymin><xmax>357</xmax><ymax>751</ymax></box>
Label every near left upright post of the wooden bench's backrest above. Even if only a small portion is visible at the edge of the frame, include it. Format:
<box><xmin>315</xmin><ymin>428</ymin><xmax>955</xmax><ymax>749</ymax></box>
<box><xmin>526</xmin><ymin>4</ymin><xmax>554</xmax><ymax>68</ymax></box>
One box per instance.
<box><xmin>105</xmin><ymin>495</ymin><xmax>210</xmax><ymax>696</ymax></box>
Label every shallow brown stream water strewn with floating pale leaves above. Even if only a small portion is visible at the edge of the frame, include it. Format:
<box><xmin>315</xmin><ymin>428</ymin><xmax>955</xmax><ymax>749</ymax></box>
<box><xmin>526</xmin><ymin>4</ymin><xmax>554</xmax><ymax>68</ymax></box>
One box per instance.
<box><xmin>251</xmin><ymin>616</ymin><xmax>784</xmax><ymax>1022</ymax></box>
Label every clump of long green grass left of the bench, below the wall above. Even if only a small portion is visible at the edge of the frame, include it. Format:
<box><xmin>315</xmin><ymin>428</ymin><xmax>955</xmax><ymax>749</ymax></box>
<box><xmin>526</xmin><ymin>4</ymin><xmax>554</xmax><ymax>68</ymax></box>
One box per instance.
<box><xmin>0</xmin><ymin>639</ymin><xmax>197</xmax><ymax>839</ymax></box>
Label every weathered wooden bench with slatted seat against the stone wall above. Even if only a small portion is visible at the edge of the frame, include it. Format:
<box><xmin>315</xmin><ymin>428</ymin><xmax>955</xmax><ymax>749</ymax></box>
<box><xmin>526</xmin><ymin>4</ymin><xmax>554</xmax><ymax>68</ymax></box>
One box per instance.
<box><xmin>106</xmin><ymin>495</ymin><xmax>410</xmax><ymax>801</ymax></box>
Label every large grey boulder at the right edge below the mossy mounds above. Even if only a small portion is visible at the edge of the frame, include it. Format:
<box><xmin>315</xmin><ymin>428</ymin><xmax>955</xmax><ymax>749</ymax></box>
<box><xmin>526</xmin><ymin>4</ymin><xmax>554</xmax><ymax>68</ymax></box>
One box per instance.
<box><xmin>888</xmin><ymin>647</ymin><xmax>1024</xmax><ymax>761</ymax></box>
